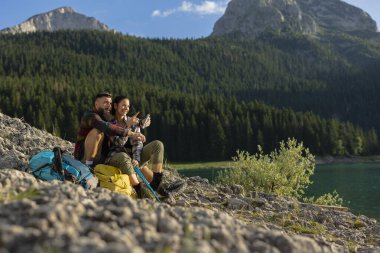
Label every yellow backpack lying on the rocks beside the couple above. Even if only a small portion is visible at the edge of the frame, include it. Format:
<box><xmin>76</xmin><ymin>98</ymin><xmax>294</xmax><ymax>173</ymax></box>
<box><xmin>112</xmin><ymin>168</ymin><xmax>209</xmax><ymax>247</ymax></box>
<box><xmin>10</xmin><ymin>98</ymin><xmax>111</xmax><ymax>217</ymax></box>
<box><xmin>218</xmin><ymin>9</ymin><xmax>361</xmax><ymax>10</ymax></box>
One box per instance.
<box><xmin>94</xmin><ymin>164</ymin><xmax>136</xmax><ymax>198</ymax></box>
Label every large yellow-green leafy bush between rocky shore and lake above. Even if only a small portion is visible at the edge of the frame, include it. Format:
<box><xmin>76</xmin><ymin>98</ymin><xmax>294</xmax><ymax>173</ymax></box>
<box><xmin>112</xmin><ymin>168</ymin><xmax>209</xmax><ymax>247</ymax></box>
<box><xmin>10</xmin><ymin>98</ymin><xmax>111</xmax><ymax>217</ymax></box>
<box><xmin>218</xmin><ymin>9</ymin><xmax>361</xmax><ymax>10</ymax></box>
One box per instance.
<box><xmin>216</xmin><ymin>139</ymin><xmax>315</xmax><ymax>198</ymax></box>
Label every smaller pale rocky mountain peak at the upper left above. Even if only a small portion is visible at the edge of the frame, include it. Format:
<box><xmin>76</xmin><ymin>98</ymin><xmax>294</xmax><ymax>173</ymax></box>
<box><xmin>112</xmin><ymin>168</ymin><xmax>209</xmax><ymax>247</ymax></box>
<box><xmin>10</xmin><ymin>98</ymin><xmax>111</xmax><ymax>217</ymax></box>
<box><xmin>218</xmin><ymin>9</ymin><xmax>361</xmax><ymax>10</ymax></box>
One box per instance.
<box><xmin>0</xmin><ymin>7</ymin><xmax>110</xmax><ymax>34</ymax></box>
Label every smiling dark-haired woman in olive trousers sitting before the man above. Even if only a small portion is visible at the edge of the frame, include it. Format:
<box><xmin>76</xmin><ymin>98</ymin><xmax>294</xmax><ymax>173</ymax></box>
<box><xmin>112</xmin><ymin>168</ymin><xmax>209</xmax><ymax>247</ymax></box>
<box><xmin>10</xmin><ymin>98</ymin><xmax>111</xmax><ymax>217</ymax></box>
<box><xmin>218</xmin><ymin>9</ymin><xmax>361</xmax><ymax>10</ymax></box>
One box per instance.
<box><xmin>106</xmin><ymin>96</ymin><xmax>172</xmax><ymax>198</ymax></box>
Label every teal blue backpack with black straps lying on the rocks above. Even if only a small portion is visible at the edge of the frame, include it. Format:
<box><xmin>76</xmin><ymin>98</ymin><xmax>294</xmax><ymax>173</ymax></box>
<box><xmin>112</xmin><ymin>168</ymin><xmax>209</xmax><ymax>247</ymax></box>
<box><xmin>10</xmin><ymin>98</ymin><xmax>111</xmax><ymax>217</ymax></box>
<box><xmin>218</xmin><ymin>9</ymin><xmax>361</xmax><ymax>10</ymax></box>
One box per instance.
<box><xmin>29</xmin><ymin>147</ymin><xmax>97</xmax><ymax>189</ymax></box>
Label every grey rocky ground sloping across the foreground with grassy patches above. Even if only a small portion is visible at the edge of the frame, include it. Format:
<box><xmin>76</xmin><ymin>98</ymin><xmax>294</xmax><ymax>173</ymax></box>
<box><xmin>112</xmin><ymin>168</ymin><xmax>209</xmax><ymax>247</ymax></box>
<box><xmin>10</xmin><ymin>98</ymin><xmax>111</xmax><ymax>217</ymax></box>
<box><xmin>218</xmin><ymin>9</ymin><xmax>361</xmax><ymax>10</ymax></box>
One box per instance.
<box><xmin>0</xmin><ymin>113</ymin><xmax>380</xmax><ymax>253</ymax></box>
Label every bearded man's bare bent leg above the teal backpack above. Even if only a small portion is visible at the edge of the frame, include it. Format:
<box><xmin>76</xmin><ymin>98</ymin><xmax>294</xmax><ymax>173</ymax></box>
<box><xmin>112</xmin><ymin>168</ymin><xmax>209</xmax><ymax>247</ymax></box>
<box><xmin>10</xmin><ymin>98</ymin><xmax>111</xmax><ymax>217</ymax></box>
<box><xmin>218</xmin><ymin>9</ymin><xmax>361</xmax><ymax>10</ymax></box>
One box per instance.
<box><xmin>84</xmin><ymin>128</ymin><xmax>104</xmax><ymax>166</ymax></box>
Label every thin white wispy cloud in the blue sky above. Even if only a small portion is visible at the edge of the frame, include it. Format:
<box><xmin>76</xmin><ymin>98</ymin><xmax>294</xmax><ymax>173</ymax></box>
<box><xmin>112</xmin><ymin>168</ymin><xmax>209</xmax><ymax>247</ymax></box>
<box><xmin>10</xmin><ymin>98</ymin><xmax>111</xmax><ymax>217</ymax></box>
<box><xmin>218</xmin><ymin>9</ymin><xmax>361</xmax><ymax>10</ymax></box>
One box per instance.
<box><xmin>152</xmin><ymin>0</ymin><xmax>230</xmax><ymax>17</ymax></box>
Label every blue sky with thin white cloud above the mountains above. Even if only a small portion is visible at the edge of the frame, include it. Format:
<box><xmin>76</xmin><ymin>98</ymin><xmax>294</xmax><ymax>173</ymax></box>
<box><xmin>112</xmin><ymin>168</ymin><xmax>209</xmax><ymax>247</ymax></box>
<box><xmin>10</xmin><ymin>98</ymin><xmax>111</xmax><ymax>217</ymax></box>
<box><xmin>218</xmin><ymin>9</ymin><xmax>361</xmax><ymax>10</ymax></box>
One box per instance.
<box><xmin>0</xmin><ymin>0</ymin><xmax>380</xmax><ymax>38</ymax></box>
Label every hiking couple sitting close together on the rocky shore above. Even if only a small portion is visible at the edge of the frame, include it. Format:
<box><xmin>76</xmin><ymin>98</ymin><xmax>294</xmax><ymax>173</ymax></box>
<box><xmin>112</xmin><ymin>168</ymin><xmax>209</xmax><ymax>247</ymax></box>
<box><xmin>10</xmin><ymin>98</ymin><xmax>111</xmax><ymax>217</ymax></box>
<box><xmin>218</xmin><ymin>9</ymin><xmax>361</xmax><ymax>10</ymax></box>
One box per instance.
<box><xmin>74</xmin><ymin>93</ymin><xmax>184</xmax><ymax>198</ymax></box>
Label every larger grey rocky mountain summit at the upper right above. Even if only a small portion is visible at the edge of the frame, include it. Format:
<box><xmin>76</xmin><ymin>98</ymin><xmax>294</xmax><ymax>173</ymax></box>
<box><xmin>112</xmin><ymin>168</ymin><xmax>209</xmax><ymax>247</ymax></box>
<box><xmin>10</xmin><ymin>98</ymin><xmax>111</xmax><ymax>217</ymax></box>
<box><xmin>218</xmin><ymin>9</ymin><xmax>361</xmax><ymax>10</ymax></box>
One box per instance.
<box><xmin>211</xmin><ymin>0</ymin><xmax>377</xmax><ymax>37</ymax></box>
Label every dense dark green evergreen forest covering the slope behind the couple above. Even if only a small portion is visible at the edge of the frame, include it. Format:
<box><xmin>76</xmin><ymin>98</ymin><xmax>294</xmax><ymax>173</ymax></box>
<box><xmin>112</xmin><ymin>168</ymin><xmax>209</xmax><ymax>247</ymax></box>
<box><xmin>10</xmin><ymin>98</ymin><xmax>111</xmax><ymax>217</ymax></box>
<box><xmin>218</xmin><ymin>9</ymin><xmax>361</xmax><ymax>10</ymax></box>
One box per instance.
<box><xmin>0</xmin><ymin>31</ymin><xmax>380</xmax><ymax>161</ymax></box>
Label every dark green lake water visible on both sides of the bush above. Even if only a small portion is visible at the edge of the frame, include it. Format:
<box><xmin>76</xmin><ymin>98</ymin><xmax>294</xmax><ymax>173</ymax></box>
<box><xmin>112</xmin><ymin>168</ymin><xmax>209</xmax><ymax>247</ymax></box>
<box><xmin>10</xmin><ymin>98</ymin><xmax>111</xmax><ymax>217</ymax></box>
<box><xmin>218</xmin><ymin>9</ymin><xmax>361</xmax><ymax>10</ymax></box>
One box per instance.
<box><xmin>179</xmin><ymin>163</ymin><xmax>380</xmax><ymax>220</ymax></box>
